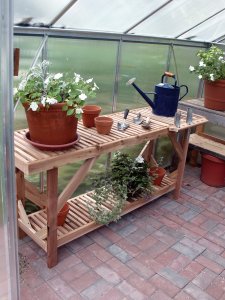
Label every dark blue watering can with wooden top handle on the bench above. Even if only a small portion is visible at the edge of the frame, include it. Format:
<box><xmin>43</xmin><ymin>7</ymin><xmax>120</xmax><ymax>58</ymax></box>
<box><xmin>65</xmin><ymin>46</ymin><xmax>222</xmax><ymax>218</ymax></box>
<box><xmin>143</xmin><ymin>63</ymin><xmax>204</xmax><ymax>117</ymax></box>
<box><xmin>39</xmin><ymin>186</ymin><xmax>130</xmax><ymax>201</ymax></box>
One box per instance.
<box><xmin>127</xmin><ymin>72</ymin><xmax>188</xmax><ymax>117</ymax></box>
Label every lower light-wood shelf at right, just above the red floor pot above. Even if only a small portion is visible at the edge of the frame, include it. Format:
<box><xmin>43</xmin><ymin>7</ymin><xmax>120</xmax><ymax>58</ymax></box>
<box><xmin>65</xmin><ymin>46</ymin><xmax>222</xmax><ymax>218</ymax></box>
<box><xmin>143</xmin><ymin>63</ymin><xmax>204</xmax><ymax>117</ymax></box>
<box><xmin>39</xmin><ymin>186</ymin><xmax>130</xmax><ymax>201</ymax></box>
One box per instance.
<box><xmin>189</xmin><ymin>133</ymin><xmax>225</xmax><ymax>159</ymax></box>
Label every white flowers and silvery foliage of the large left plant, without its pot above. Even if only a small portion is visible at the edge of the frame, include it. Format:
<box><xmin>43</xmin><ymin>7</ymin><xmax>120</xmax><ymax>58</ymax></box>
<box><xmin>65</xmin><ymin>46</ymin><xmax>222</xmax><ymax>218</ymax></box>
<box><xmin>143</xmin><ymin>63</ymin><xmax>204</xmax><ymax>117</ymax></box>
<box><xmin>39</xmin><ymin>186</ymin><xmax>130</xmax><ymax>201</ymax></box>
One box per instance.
<box><xmin>14</xmin><ymin>61</ymin><xmax>99</xmax><ymax>117</ymax></box>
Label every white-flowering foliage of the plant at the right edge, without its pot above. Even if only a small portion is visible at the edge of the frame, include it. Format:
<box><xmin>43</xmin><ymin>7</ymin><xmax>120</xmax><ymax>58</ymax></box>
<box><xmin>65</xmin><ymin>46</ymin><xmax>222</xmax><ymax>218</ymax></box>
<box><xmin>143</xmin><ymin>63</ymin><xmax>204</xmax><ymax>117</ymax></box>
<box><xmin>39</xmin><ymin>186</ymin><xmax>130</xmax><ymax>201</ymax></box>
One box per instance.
<box><xmin>189</xmin><ymin>46</ymin><xmax>225</xmax><ymax>81</ymax></box>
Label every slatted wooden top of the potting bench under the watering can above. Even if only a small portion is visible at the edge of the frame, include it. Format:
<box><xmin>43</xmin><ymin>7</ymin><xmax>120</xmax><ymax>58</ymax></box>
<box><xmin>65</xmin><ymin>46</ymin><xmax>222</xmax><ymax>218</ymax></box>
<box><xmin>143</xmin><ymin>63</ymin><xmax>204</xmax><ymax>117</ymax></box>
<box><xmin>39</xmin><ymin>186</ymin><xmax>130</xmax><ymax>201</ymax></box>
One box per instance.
<box><xmin>14</xmin><ymin>107</ymin><xmax>207</xmax><ymax>175</ymax></box>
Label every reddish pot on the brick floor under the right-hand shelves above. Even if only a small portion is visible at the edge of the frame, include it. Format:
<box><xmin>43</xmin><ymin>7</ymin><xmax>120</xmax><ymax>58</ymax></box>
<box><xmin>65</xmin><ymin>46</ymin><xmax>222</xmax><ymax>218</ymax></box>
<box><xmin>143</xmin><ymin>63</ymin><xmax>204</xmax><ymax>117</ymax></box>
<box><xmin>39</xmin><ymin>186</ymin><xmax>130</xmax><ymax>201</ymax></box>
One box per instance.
<box><xmin>200</xmin><ymin>154</ymin><xmax>225</xmax><ymax>187</ymax></box>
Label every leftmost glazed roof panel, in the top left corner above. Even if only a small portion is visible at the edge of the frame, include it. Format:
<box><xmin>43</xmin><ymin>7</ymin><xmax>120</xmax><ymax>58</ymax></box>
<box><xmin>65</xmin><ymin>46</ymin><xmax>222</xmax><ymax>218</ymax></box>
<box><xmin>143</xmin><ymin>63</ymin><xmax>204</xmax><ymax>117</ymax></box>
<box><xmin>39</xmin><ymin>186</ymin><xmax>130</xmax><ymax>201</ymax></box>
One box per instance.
<box><xmin>14</xmin><ymin>0</ymin><xmax>70</xmax><ymax>25</ymax></box>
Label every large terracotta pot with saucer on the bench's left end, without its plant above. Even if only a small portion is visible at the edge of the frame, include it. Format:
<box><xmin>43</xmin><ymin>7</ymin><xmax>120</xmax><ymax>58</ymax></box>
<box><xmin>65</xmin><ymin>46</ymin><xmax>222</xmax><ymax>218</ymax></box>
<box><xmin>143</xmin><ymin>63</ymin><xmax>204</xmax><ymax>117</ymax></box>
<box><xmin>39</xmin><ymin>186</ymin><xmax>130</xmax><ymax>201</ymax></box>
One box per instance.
<box><xmin>24</xmin><ymin>103</ymin><xmax>78</xmax><ymax>145</ymax></box>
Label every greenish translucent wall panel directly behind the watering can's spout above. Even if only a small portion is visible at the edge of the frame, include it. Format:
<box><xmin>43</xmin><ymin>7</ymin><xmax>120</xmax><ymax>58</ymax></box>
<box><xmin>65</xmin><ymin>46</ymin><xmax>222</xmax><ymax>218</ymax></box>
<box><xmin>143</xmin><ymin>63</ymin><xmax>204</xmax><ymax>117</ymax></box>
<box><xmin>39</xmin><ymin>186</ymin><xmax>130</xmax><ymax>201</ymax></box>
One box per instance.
<box><xmin>117</xmin><ymin>43</ymin><xmax>168</xmax><ymax>110</ymax></box>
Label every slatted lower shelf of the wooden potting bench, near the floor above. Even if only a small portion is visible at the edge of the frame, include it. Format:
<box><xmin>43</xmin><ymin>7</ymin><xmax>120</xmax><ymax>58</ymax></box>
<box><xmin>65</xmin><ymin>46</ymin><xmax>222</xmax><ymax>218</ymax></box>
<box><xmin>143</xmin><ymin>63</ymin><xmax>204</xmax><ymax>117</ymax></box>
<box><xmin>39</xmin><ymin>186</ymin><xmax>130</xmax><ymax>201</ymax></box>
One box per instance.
<box><xmin>18</xmin><ymin>176</ymin><xmax>175</xmax><ymax>252</ymax></box>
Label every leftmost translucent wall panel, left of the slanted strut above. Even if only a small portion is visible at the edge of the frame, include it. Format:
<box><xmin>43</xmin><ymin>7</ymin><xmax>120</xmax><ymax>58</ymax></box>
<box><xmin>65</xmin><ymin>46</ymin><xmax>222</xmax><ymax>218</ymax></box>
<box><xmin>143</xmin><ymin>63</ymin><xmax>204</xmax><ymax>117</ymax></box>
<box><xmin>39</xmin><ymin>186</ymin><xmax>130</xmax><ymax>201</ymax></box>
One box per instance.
<box><xmin>13</xmin><ymin>36</ymin><xmax>42</xmax><ymax>129</ymax></box>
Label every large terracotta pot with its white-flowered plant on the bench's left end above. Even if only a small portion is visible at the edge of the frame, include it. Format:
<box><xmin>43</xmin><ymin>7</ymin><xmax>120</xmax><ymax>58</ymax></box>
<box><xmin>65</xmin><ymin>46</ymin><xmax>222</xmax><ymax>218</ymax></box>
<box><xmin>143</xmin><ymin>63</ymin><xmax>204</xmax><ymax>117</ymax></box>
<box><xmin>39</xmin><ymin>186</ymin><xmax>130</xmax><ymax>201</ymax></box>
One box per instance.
<box><xmin>14</xmin><ymin>61</ymin><xmax>98</xmax><ymax>148</ymax></box>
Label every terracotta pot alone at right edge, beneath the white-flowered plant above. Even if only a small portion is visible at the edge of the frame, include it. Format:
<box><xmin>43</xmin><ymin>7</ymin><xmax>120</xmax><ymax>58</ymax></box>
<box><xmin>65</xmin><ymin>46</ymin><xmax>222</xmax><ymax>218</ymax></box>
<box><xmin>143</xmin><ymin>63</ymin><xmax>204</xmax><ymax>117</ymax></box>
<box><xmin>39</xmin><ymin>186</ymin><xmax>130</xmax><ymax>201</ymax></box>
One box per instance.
<box><xmin>204</xmin><ymin>80</ymin><xmax>225</xmax><ymax>111</ymax></box>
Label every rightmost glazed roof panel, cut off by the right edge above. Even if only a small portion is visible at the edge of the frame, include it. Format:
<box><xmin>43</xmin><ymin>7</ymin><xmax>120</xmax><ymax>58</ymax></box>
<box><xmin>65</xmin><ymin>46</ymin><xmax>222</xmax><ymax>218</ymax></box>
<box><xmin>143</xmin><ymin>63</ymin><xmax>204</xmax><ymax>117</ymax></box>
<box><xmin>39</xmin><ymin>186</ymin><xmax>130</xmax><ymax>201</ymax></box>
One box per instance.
<box><xmin>180</xmin><ymin>11</ymin><xmax>225</xmax><ymax>41</ymax></box>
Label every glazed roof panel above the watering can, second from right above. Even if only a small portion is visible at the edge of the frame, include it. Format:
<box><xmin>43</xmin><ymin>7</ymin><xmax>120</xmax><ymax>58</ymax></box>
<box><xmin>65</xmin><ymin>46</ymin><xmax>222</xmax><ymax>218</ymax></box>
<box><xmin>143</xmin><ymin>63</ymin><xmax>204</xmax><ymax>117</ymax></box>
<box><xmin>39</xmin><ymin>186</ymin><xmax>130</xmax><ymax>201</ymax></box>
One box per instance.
<box><xmin>133</xmin><ymin>0</ymin><xmax>225</xmax><ymax>40</ymax></box>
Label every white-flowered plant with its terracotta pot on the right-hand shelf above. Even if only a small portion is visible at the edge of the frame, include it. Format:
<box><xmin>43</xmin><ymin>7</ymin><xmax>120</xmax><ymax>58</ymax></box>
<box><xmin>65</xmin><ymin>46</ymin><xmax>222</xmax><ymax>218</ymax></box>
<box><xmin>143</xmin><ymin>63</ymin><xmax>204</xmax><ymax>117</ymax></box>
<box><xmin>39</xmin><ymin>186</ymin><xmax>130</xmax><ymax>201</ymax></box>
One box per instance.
<box><xmin>189</xmin><ymin>46</ymin><xmax>225</xmax><ymax>111</ymax></box>
